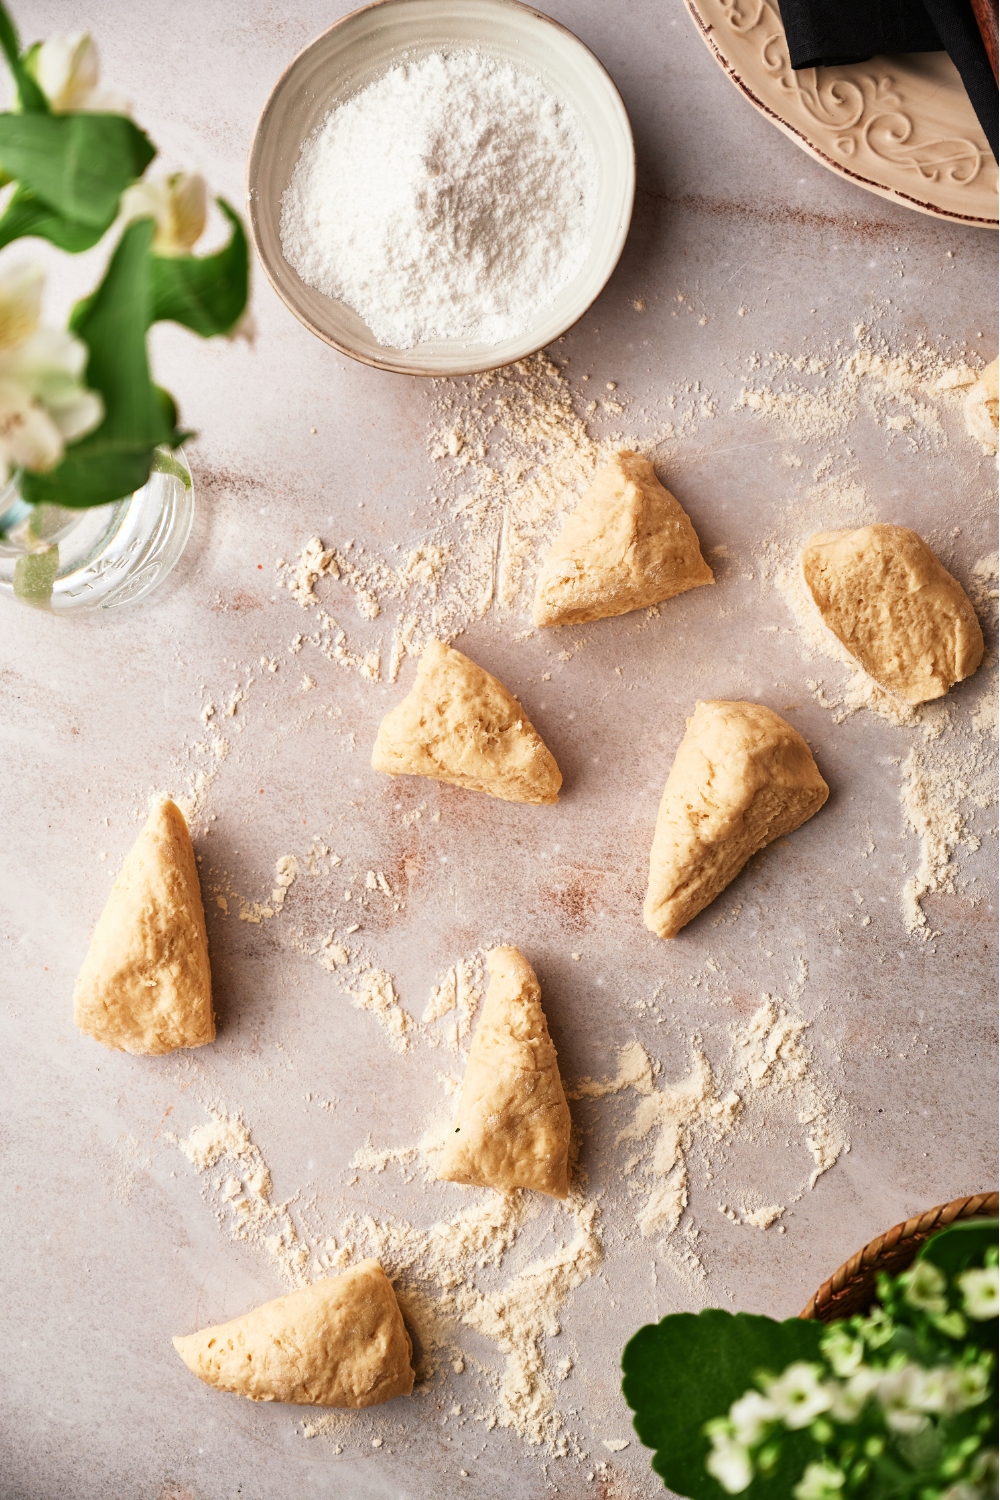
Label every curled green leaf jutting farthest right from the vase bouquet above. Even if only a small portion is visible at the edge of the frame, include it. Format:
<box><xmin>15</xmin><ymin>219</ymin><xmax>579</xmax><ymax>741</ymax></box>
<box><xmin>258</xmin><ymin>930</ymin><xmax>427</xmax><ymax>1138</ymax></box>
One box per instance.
<box><xmin>148</xmin><ymin>198</ymin><xmax>250</xmax><ymax>339</ymax></box>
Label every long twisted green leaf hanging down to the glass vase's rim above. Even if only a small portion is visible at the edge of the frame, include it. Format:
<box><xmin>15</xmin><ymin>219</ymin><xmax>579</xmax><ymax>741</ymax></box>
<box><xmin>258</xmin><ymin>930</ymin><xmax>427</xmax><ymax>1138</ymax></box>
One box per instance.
<box><xmin>22</xmin><ymin>219</ymin><xmax>181</xmax><ymax>509</ymax></box>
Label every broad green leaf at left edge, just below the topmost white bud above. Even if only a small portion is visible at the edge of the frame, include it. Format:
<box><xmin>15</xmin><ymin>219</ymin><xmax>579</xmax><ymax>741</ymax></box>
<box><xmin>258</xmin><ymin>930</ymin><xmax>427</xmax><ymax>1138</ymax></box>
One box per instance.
<box><xmin>0</xmin><ymin>114</ymin><xmax>156</xmax><ymax>234</ymax></box>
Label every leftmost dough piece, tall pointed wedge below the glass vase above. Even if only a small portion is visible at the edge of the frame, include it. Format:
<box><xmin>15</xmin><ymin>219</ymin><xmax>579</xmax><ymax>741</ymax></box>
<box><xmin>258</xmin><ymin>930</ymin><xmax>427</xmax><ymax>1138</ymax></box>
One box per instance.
<box><xmin>73</xmin><ymin>801</ymin><xmax>216</xmax><ymax>1053</ymax></box>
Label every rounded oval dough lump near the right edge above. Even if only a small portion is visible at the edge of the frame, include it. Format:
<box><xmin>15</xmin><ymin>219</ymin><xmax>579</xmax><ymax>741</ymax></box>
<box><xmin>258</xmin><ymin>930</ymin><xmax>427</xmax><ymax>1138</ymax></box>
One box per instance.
<box><xmin>802</xmin><ymin>525</ymin><xmax>984</xmax><ymax>704</ymax></box>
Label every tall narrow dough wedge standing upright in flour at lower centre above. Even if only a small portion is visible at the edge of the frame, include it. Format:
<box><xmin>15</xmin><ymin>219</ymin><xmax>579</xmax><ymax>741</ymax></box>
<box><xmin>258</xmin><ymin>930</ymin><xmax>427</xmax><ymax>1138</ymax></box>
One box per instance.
<box><xmin>438</xmin><ymin>948</ymin><xmax>570</xmax><ymax>1199</ymax></box>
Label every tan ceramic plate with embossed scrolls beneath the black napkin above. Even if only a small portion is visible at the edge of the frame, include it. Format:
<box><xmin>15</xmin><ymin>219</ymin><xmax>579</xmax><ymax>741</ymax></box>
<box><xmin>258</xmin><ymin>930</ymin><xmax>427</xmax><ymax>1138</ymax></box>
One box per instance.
<box><xmin>685</xmin><ymin>0</ymin><xmax>999</xmax><ymax>230</ymax></box>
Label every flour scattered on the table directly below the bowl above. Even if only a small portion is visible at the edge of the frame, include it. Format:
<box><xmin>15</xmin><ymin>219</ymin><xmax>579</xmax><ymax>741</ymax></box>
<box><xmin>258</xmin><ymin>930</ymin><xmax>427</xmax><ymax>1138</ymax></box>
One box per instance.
<box><xmin>277</xmin><ymin>354</ymin><xmax>616</xmax><ymax>683</ymax></box>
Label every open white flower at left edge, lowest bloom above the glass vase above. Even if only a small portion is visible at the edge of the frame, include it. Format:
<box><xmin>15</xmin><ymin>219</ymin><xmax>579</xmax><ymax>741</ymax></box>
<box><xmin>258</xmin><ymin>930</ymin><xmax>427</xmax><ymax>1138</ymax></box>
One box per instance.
<box><xmin>0</xmin><ymin>266</ymin><xmax>103</xmax><ymax>483</ymax></box>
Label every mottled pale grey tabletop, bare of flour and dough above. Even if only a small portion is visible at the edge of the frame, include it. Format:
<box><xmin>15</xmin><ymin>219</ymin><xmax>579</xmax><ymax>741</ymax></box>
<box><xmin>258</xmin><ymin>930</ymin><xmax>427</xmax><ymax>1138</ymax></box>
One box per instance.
<box><xmin>0</xmin><ymin>0</ymin><xmax>996</xmax><ymax>1500</ymax></box>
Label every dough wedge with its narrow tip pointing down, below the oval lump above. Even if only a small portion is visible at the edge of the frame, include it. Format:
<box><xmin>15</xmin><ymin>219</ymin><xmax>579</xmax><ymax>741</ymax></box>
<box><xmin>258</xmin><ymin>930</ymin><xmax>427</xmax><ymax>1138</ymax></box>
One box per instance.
<box><xmin>643</xmin><ymin>702</ymin><xmax>829</xmax><ymax>938</ymax></box>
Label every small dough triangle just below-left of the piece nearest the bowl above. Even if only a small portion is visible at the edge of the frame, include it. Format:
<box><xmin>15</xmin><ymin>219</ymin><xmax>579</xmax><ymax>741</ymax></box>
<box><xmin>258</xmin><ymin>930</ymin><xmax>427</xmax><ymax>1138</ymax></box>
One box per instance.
<box><xmin>372</xmin><ymin>641</ymin><xmax>562</xmax><ymax>803</ymax></box>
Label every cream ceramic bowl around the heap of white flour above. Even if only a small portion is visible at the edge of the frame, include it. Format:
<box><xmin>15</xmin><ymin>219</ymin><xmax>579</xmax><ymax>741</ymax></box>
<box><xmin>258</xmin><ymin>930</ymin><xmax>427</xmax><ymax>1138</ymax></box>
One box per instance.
<box><xmin>246</xmin><ymin>0</ymin><xmax>636</xmax><ymax>375</ymax></box>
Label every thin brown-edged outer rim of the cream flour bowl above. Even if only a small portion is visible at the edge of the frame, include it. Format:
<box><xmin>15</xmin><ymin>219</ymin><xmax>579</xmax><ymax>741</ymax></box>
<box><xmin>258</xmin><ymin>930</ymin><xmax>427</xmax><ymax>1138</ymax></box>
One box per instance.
<box><xmin>244</xmin><ymin>0</ymin><xmax>636</xmax><ymax>378</ymax></box>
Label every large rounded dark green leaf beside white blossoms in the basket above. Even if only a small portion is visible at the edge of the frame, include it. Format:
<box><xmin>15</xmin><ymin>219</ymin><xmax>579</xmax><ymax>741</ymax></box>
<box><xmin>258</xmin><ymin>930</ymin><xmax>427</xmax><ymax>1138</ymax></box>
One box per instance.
<box><xmin>622</xmin><ymin>1308</ymin><xmax>823</xmax><ymax>1500</ymax></box>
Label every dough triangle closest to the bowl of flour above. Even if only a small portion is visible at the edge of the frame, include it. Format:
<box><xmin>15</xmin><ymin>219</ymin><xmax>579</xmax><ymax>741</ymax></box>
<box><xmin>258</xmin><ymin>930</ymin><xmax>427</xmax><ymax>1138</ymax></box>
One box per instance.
<box><xmin>534</xmin><ymin>450</ymin><xmax>715</xmax><ymax>626</ymax></box>
